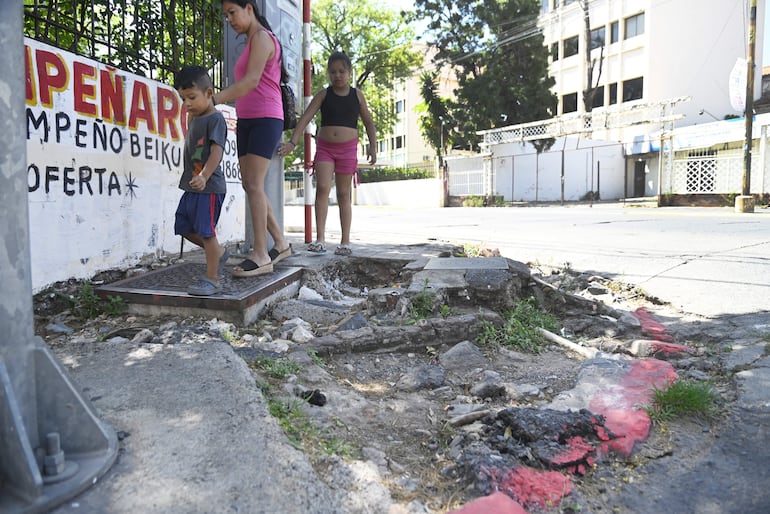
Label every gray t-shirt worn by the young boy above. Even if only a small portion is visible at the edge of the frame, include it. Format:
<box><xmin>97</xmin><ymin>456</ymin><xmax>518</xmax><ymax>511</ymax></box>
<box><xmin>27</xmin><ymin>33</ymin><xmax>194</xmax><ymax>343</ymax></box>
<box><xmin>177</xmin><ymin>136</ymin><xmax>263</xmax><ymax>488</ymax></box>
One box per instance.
<box><xmin>179</xmin><ymin>111</ymin><xmax>227</xmax><ymax>194</ymax></box>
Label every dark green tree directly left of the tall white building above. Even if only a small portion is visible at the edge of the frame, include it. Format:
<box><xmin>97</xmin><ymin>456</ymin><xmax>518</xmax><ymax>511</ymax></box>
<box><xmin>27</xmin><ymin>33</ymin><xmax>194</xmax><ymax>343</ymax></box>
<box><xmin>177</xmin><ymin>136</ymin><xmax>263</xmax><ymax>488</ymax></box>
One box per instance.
<box><xmin>415</xmin><ymin>0</ymin><xmax>557</xmax><ymax>149</ymax></box>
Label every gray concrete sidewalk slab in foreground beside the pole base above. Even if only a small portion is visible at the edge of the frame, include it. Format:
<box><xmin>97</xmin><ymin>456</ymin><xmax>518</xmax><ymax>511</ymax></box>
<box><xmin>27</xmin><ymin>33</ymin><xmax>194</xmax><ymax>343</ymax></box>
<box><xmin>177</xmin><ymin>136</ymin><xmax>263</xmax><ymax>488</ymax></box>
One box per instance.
<box><xmin>52</xmin><ymin>334</ymin><xmax>344</xmax><ymax>514</ymax></box>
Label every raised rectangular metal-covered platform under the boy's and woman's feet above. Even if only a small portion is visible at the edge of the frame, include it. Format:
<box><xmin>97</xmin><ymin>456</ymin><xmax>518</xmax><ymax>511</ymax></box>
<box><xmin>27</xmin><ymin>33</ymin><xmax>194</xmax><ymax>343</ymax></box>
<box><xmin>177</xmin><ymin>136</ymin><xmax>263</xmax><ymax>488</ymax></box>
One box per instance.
<box><xmin>101</xmin><ymin>262</ymin><xmax>302</xmax><ymax>325</ymax></box>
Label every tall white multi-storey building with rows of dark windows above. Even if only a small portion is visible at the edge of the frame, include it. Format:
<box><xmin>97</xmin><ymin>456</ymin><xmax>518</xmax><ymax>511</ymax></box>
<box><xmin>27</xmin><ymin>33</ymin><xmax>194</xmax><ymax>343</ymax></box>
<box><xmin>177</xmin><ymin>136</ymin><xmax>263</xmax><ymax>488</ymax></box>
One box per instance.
<box><xmin>539</xmin><ymin>0</ymin><xmax>765</xmax><ymax>140</ymax></box>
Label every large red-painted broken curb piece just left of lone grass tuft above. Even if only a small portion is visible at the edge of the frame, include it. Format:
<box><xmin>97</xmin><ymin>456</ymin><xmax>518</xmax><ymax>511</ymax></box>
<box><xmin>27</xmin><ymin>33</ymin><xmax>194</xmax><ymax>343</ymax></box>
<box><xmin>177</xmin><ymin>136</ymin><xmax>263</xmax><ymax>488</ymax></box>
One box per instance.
<box><xmin>588</xmin><ymin>359</ymin><xmax>676</xmax><ymax>456</ymax></box>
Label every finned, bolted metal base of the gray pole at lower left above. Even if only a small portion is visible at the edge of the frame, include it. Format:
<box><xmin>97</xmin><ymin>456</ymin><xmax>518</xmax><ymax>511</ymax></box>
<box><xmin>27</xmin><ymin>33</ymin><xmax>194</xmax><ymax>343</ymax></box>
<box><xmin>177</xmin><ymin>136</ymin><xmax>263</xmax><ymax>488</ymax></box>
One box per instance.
<box><xmin>0</xmin><ymin>337</ymin><xmax>118</xmax><ymax>514</ymax></box>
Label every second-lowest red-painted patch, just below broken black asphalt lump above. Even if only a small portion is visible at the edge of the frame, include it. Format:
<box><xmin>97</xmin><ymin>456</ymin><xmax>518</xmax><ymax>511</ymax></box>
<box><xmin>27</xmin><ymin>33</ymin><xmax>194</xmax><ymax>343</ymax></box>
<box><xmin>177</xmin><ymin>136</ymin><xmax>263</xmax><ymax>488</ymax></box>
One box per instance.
<box><xmin>484</xmin><ymin>466</ymin><xmax>572</xmax><ymax>508</ymax></box>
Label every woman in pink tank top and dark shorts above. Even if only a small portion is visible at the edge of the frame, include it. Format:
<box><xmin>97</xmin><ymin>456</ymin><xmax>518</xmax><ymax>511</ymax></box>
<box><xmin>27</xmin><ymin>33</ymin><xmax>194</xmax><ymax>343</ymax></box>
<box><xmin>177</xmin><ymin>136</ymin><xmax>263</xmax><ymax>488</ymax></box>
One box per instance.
<box><xmin>214</xmin><ymin>0</ymin><xmax>291</xmax><ymax>277</ymax></box>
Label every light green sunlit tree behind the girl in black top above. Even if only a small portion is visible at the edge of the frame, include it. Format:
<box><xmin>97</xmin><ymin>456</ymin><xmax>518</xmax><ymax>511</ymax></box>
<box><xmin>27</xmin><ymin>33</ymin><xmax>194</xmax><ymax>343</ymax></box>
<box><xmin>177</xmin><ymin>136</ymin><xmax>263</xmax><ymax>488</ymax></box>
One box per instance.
<box><xmin>311</xmin><ymin>0</ymin><xmax>422</xmax><ymax>147</ymax></box>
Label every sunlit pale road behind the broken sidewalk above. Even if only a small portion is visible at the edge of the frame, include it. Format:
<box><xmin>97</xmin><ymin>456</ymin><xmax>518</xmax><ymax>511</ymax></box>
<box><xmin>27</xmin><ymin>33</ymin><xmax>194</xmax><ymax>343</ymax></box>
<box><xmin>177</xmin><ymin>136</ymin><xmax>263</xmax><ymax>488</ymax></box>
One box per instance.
<box><xmin>284</xmin><ymin>202</ymin><xmax>770</xmax><ymax>317</ymax></box>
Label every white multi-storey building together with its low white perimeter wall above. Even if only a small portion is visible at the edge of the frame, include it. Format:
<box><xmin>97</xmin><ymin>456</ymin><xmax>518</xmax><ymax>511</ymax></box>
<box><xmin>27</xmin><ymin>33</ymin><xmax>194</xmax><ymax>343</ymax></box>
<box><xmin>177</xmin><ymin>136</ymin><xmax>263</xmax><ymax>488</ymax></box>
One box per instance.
<box><xmin>449</xmin><ymin>0</ymin><xmax>770</xmax><ymax>201</ymax></box>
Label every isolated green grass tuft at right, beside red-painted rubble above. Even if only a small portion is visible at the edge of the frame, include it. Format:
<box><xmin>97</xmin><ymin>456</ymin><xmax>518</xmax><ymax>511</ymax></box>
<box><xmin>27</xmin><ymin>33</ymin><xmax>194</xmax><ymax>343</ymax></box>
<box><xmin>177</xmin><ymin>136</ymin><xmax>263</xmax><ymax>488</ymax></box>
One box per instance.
<box><xmin>644</xmin><ymin>380</ymin><xmax>718</xmax><ymax>423</ymax></box>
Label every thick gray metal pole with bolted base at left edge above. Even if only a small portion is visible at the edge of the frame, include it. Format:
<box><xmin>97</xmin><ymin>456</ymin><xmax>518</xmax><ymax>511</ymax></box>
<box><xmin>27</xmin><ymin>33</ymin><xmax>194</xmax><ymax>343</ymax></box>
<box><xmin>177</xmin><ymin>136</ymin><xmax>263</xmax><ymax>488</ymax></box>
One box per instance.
<box><xmin>0</xmin><ymin>0</ymin><xmax>118</xmax><ymax>514</ymax></box>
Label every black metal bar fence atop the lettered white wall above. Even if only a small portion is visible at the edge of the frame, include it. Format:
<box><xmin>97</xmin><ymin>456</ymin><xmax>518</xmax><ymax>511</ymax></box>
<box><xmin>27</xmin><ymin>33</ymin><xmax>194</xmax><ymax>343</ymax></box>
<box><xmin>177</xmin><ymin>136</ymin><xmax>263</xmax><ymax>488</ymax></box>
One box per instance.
<box><xmin>24</xmin><ymin>0</ymin><xmax>224</xmax><ymax>89</ymax></box>
